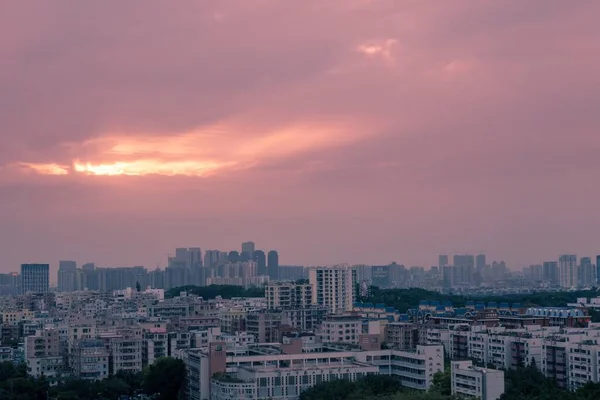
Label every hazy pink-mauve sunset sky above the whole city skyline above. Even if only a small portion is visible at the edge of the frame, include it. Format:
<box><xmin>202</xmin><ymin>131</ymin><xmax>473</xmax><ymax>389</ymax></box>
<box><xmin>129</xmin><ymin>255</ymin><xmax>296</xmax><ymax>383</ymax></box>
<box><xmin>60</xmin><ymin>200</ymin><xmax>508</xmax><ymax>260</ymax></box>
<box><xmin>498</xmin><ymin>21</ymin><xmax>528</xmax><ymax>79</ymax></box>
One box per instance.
<box><xmin>0</xmin><ymin>0</ymin><xmax>600</xmax><ymax>272</ymax></box>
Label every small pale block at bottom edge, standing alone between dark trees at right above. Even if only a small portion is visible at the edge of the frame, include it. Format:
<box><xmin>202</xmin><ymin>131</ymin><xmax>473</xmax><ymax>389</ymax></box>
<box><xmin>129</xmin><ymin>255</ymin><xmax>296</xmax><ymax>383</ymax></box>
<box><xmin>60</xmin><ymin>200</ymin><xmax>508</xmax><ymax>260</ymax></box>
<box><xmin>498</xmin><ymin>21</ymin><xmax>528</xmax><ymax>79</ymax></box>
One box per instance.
<box><xmin>451</xmin><ymin>361</ymin><xmax>504</xmax><ymax>400</ymax></box>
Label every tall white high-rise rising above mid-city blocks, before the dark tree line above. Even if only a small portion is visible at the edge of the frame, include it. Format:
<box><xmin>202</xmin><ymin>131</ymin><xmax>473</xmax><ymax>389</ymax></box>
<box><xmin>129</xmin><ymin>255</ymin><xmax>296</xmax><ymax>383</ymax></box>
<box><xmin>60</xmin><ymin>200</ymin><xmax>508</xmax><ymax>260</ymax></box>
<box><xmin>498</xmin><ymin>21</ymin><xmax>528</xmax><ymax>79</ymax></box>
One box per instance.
<box><xmin>308</xmin><ymin>265</ymin><xmax>358</xmax><ymax>314</ymax></box>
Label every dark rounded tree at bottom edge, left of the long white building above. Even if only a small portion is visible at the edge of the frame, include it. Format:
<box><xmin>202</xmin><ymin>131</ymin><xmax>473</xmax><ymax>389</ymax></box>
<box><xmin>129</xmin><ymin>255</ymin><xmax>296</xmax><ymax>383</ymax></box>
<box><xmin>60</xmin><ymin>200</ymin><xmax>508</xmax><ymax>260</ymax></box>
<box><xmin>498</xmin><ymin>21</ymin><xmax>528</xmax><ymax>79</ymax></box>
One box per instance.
<box><xmin>142</xmin><ymin>357</ymin><xmax>186</xmax><ymax>400</ymax></box>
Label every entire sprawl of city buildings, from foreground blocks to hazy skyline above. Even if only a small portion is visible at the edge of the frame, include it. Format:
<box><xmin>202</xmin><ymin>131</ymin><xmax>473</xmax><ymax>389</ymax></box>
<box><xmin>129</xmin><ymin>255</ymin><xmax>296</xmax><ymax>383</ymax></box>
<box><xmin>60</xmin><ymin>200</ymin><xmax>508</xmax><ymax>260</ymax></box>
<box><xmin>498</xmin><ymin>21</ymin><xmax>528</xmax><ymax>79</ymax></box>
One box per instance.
<box><xmin>0</xmin><ymin>250</ymin><xmax>600</xmax><ymax>400</ymax></box>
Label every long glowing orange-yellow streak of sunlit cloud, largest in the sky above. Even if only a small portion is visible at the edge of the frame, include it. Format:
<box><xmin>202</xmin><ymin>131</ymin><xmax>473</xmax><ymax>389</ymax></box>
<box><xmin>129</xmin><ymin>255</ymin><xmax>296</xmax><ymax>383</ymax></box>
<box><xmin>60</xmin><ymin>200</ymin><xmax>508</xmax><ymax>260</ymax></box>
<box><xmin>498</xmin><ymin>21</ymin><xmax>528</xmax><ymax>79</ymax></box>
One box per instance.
<box><xmin>16</xmin><ymin>119</ymin><xmax>368</xmax><ymax>177</ymax></box>
